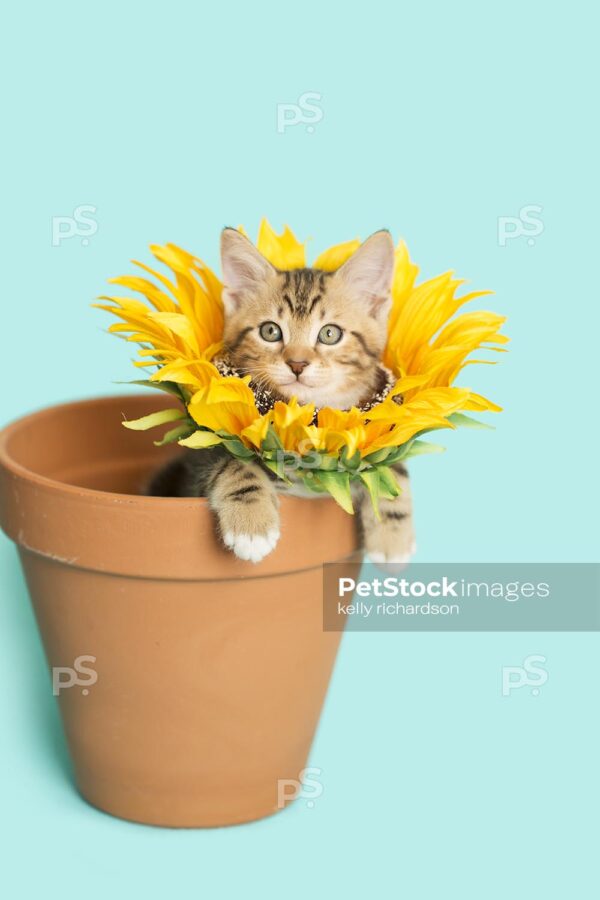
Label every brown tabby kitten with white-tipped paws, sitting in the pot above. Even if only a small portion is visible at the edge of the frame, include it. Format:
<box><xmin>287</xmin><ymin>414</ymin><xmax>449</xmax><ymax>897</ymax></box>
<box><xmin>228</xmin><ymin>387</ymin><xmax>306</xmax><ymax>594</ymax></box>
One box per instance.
<box><xmin>149</xmin><ymin>228</ymin><xmax>414</xmax><ymax>562</ymax></box>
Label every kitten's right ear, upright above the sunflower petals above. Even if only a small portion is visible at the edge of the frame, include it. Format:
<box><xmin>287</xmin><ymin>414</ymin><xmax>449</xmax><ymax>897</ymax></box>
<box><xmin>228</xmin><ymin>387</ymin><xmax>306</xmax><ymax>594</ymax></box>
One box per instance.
<box><xmin>336</xmin><ymin>231</ymin><xmax>395</xmax><ymax>318</ymax></box>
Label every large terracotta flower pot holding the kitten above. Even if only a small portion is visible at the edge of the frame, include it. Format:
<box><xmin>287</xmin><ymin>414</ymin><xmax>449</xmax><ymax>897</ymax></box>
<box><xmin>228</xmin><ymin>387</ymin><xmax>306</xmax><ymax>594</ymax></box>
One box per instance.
<box><xmin>0</xmin><ymin>395</ymin><xmax>356</xmax><ymax>827</ymax></box>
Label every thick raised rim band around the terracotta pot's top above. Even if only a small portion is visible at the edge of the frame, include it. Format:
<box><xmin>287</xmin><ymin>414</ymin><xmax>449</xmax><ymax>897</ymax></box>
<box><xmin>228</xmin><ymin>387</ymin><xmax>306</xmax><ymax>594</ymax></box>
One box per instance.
<box><xmin>0</xmin><ymin>392</ymin><xmax>358</xmax><ymax>581</ymax></box>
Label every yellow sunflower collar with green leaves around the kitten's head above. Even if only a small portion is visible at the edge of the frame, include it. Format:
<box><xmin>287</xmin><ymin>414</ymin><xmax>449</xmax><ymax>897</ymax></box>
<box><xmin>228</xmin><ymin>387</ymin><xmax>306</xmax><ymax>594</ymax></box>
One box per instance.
<box><xmin>96</xmin><ymin>220</ymin><xmax>508</xmax><ymax>512</ymax></box>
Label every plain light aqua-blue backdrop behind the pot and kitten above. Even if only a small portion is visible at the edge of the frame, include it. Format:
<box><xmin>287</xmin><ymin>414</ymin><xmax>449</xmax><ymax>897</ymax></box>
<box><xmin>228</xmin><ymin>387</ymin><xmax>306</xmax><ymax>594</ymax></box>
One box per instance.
<box><xmin>0</xmin><ymin>0</ymin><xmax>598</xmax><ymax>900</ymax></box>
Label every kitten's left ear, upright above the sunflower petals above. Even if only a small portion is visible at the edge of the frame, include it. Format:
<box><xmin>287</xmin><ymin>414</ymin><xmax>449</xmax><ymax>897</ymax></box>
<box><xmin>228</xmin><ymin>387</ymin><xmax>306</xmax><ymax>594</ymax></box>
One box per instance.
<box><xmin>221</xmin><ymin>228</ymin><xmax>275</xmax><ymax>312</ymax></box>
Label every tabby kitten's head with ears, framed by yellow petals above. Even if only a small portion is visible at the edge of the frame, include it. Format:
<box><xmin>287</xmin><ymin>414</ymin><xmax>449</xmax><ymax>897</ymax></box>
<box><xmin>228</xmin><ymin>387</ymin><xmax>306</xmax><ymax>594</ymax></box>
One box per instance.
<box><xmin>221</xmin><ymin>228</ymin><xmax>394</xmax><ymax>409</ymax></box>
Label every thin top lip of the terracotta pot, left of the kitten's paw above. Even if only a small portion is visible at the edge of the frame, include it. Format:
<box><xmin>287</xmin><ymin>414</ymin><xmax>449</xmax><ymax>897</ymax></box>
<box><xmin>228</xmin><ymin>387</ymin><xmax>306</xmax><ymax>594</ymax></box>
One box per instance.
<box><xmin>0</xmin><ymin>392</ymin><xmax>208</xmax><ymax>509</ymax></box>
